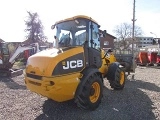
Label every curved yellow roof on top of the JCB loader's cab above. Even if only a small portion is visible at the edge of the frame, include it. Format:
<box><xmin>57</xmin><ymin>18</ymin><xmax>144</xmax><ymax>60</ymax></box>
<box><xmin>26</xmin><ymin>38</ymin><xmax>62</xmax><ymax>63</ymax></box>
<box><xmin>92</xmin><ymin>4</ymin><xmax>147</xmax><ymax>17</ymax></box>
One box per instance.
<box><xmin>55</xmin><ymin>15</ymin><xmax>98</xmax><ymax>25</ymax></box>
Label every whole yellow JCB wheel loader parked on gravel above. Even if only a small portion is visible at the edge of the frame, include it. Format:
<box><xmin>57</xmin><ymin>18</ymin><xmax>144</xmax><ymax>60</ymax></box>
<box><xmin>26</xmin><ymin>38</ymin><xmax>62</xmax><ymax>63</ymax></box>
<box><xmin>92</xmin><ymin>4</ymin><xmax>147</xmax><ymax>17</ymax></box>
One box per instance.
<box><xmin>24</xmin><ymin>15</ymin><xmax>125</xmax><ymax>110</ymax></box>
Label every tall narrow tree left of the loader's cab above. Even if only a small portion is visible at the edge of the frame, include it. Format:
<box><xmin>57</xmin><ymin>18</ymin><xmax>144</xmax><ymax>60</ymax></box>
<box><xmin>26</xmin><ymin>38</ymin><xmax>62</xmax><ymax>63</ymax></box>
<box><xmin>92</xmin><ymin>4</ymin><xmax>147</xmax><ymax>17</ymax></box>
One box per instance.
<box><xmin>25</xmin><ymin>11</ymin><xmax>47</xmax><ymax>42</ymax></box>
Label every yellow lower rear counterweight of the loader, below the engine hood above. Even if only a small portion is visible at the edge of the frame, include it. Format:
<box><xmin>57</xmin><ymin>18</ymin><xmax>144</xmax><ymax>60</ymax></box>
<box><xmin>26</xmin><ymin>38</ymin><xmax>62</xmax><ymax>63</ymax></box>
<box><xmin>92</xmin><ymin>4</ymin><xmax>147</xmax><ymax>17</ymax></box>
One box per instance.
<box><xmin>25</xmin><ymin>73</ymin><xmax>80</xmax><ymax>102</ymax></box>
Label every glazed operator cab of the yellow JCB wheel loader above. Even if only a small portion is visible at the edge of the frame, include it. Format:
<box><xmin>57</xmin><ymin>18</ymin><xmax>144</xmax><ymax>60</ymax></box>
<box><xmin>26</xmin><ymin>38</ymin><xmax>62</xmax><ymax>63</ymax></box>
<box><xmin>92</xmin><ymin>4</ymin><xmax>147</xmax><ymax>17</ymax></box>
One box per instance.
<box><xmin>51</xmin><ymin>16</ymin><xmax>105</xmax><ymax>68</ymax></box>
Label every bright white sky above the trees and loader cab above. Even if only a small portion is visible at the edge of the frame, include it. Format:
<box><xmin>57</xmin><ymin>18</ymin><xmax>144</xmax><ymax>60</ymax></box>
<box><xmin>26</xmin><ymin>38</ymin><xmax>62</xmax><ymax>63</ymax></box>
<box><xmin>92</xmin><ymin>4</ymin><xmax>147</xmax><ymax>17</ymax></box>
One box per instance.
<box><xmin>0</xmin><ymin>0</ymin><xmax>160</xmax><ymax>42</ymax></box>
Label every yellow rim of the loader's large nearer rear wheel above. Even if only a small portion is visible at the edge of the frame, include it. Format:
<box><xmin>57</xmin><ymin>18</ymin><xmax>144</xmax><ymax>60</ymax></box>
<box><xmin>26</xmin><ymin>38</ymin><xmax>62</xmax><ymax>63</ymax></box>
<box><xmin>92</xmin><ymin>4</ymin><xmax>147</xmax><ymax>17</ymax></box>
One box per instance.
<box><xmin>90</xmin><ymin>82</ymin><xmax>100</xmax><ymax>103</ymax></box>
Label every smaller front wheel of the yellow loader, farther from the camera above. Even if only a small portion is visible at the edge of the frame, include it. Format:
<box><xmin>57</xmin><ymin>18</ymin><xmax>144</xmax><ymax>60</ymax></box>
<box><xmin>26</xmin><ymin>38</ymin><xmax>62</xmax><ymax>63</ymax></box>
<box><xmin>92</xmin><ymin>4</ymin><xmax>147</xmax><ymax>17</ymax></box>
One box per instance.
<box><xmin>107</xmin><ymin>62</ymin><xmax>125</xmax><ymax>90</ymax></box>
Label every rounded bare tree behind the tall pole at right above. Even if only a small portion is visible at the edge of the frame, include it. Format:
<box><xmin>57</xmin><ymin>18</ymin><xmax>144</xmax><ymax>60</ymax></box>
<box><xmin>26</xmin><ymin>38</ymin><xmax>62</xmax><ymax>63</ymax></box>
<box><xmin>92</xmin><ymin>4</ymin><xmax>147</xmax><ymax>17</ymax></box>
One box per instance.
<box><xmin>113</xmin><ymin>23</ymin><xmax>143</xmax><ymax>48</ymax></box>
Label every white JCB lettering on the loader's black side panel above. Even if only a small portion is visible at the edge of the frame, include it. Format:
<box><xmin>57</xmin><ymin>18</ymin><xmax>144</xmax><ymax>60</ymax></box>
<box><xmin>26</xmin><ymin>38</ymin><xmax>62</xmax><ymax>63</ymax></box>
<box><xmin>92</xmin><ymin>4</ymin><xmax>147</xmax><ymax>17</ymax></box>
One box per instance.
<box><xmin>62</xmin><ymin>60</ymin><xmax>83</xmax><ymax>70</ymax></box>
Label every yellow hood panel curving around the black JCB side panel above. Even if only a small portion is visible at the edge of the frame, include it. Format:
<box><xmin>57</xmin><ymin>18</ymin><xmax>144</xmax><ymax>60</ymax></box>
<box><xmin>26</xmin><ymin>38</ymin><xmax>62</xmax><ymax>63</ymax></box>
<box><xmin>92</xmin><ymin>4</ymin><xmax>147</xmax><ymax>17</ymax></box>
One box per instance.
<box><xmin>26</xmin><ymin>47</ymin><xmax>84</xmax><ymax>76</ymax></box>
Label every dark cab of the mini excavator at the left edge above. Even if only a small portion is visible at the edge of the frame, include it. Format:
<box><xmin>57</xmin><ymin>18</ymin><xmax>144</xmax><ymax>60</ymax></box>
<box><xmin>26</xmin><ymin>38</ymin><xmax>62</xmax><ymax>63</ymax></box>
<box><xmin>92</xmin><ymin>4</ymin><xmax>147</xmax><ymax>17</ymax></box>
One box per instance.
<box><xmin>0</xmin><ymin>43</ymin><xmax>10</xmax><ymax>64</ymax></box>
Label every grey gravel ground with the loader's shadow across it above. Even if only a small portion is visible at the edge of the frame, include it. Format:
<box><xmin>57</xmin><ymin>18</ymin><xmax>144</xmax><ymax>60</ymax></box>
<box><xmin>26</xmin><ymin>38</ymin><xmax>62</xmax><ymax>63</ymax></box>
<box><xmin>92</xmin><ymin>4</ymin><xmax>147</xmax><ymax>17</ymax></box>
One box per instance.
<box><xmin>0</xmin><ymin>67</ymin><xmax>160</xmax><ymax>120</ymax></box>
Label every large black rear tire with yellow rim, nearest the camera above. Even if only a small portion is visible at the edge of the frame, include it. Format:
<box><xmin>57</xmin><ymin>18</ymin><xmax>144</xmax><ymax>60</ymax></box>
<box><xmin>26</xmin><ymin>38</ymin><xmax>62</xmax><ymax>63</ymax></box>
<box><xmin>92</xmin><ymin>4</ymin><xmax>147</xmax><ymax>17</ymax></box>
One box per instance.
<box><xmin>75</xmin><ymin>74</ymin><xmax>103</xmax><ymax>110</ymax></box>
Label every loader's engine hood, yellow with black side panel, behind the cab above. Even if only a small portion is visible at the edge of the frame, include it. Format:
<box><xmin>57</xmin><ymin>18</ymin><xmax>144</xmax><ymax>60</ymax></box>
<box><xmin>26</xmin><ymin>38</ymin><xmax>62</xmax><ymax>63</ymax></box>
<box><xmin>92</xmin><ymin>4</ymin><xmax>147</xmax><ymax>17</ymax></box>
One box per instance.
<box><xmin>26</xmin><ymin>47</ymin><xmax>84</xmax><ymax>76</ymax></box>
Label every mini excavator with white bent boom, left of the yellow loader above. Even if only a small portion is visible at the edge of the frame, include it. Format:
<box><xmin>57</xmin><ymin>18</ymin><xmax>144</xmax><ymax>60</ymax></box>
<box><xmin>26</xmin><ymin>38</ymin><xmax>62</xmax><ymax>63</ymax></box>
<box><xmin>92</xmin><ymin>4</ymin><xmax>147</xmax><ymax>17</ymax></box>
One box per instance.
<box><xmin>0</xmin><ymin>42</ymin><xmax>40</xmax><ymax>77</ymax></box>
